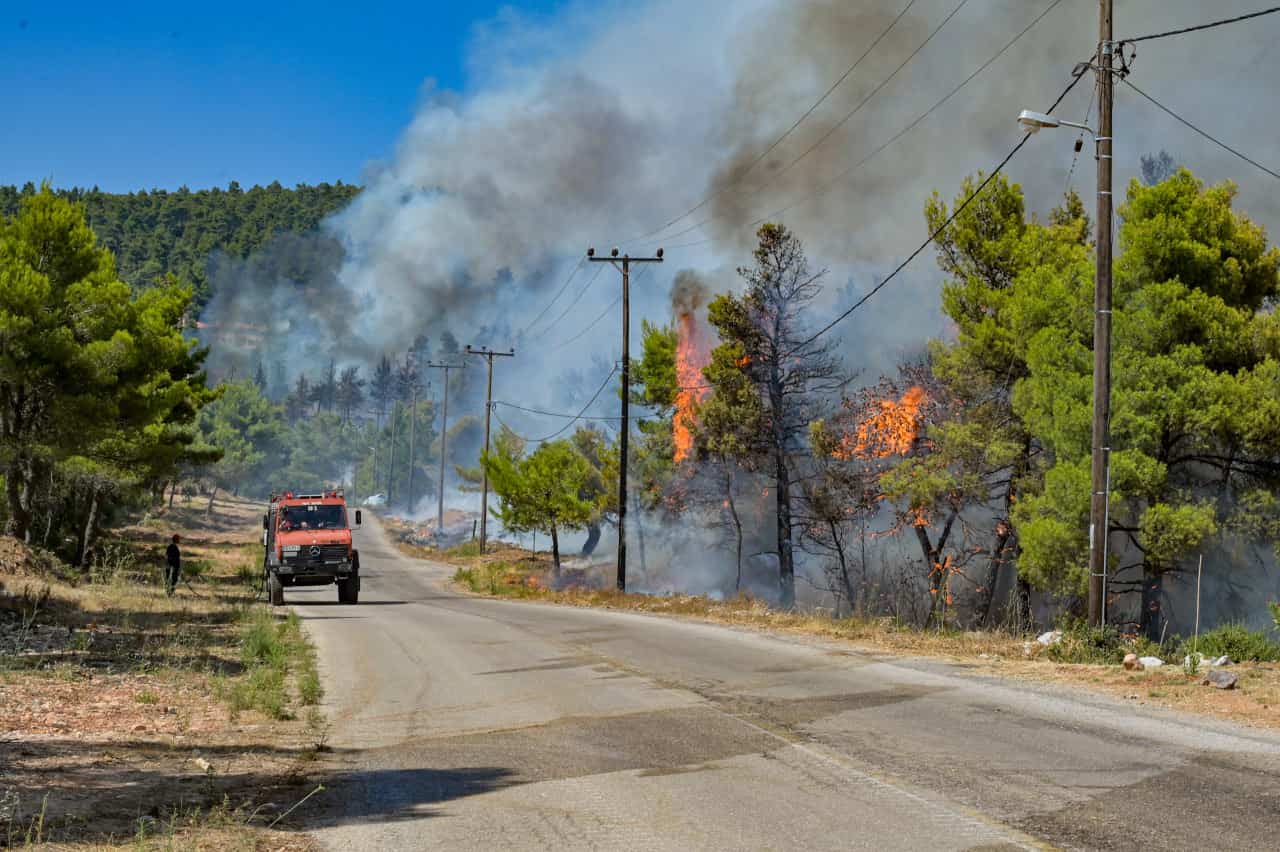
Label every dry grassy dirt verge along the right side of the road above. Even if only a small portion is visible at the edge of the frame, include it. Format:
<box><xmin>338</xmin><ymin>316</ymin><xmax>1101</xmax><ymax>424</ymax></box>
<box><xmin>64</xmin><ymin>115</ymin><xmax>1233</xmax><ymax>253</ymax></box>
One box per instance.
<box><xmin>432</xmin><ymin>545</ymin><xmax>1280</xmax><ymax>729</ymax></box>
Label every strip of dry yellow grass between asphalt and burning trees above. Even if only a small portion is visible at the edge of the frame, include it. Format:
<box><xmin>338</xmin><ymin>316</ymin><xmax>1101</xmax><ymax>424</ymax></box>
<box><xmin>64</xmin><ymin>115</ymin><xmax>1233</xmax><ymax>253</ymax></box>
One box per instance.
<box><xmin>434</xmin><ymin>545</ymin><xmax>1280</xmax><ymax>729</ymax></box>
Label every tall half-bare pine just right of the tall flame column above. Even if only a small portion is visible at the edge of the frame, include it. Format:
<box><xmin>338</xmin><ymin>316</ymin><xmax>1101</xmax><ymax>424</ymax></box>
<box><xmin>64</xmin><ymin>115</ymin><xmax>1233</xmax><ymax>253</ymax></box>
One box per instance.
<box><xmin>699</xmin><ymin>225</ymin><xmax>845</xmax><ymax>608</ymax></box>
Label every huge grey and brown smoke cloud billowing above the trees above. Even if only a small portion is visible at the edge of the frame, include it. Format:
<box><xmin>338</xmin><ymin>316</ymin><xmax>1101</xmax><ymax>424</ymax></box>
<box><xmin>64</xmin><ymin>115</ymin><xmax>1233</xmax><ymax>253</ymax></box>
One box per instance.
<box><xmin>202</xmin><ymin>0</ymin><xmax>1280</xmax><ymax>616</ymax></box>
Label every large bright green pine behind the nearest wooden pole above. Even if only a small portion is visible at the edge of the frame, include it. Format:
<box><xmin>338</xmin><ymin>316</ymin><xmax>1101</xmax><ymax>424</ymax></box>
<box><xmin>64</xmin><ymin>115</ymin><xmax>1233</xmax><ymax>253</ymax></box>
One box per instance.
<box><xmin>1012</xmin><ymin>169</ymin><xmax>1280</xmax><ymax>637</ymax></box>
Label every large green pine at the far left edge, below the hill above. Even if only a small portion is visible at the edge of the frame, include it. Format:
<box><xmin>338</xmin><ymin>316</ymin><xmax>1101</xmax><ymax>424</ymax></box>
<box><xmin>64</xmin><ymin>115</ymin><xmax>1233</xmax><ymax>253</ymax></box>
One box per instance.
<box><xmin>0</xmin><ymin>187</ymin><xmax>209</xmax><ymax>544</ymax></box>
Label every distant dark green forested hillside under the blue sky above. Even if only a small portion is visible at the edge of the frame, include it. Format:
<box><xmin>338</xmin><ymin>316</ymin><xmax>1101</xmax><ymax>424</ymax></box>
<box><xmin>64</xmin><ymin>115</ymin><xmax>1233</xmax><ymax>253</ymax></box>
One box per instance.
<box><xmin>0</xmin><ymin>180</ymin><xmax>360</xmax><ymax>306</ymax></box>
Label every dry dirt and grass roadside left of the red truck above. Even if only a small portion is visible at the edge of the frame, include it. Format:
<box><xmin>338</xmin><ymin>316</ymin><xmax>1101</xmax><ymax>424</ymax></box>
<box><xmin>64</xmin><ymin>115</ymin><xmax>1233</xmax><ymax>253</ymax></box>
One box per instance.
<box><xmin>0</xmin><ymin>500</ymin><xmax>325</xmax><ymax>851</ymax></box>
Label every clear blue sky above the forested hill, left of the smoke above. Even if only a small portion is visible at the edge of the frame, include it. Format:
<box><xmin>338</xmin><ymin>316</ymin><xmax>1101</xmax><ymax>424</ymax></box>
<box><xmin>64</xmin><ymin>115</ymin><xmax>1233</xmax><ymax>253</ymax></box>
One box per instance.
<box><xmin>0</xmin><ymin>0</ymin><xmax>559</xmax><ymax>192</ymax></box>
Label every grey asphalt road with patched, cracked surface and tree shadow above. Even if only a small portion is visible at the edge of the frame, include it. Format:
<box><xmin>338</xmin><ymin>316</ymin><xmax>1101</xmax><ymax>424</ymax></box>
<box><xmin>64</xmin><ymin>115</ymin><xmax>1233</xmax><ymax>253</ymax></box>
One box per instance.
<box><xmin>285</xmin><ymin>523</ymin><xmax>1280</xmax><ymax>851</ymax></box>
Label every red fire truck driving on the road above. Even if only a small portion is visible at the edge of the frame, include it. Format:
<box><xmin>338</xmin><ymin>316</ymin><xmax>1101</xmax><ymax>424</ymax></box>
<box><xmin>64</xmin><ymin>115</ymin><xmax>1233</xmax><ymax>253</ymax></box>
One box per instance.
<box><xmin>262</xmin><ymin>491</ymin><xmax>361</xmax><ymax>606</ymax></box>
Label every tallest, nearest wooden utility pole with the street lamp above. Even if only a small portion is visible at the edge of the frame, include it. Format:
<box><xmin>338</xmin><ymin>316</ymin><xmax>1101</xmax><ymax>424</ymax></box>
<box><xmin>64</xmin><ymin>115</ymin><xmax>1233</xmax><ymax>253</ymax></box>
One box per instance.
<box><xmin>1088</xmin><ymin>0</ymin><xmax>1115</xmax><ymax>626</ymax></box>
